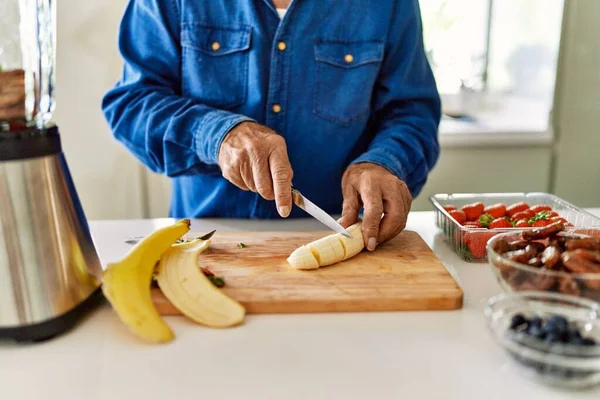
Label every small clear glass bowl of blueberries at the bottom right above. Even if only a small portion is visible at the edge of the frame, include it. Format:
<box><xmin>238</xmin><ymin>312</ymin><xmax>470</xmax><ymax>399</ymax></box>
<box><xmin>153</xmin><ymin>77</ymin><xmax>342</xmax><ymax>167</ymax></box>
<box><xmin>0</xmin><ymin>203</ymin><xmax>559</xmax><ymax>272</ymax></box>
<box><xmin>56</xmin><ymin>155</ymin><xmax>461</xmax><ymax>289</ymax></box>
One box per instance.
<box><xmin>485</xmin><ymin>292</ymin><xmax>600</xmax><ymax>389</ymax></box>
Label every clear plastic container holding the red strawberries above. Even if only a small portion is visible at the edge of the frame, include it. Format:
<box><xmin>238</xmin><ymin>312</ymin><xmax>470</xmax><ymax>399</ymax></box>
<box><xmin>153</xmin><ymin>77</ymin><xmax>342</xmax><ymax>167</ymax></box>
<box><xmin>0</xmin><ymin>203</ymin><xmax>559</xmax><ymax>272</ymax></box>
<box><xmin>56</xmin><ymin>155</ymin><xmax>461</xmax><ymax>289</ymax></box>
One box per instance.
<box><xmin>429</xmin><ymin>192</ymin><xmax>600</xmax><ymax>261</ymax></box>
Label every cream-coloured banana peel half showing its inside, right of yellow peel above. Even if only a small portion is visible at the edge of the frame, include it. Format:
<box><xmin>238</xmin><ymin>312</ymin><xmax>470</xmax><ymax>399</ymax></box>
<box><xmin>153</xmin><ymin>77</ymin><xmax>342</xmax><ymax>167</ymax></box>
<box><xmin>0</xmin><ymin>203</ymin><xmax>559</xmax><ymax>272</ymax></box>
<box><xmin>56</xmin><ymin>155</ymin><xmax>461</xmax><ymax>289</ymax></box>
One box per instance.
<box><xmin>156</xmin><ymin>239</ymin><xmax>246</xmax><ymax>328</ymax></box>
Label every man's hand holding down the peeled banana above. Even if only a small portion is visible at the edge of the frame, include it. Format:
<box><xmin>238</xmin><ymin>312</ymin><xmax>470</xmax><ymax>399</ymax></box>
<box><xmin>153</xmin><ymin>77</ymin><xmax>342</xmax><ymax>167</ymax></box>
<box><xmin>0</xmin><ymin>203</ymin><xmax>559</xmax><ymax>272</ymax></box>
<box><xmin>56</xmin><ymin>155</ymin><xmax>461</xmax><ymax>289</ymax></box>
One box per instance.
<box><xmin>340</xmin><ymin>163</ymin><xmax>412</xmax><ymax>251</ymax></box>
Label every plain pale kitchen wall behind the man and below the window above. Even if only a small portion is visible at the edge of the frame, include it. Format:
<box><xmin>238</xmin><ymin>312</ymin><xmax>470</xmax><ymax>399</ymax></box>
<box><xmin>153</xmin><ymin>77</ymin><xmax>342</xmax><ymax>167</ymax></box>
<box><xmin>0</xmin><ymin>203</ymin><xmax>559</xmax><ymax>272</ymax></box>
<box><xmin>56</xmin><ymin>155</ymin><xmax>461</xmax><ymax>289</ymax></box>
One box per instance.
<box><xmin>55</xmin><ymin>0</ymin><xmax>600</xmax><ymax>219</ymax></box>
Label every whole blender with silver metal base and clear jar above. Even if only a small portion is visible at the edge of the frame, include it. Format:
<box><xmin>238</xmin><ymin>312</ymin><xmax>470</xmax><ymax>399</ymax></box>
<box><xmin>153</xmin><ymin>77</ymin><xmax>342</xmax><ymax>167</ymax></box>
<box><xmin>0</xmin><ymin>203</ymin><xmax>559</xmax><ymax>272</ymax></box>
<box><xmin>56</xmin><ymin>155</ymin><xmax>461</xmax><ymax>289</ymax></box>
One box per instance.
<box><xmin>0</xmin><ymin>0</ymin><xmax>102</xmax><ymax>342</ymax></box>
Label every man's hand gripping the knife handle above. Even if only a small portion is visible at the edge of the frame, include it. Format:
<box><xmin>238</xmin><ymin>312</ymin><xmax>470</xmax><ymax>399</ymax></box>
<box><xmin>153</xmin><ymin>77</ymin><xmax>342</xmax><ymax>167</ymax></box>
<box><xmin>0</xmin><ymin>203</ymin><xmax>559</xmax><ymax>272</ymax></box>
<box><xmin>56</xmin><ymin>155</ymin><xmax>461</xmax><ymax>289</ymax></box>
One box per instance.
<box><xmin>219</xmin><ymin>122</ymin><xmax>293</xmax><ymax>217</ymax></box>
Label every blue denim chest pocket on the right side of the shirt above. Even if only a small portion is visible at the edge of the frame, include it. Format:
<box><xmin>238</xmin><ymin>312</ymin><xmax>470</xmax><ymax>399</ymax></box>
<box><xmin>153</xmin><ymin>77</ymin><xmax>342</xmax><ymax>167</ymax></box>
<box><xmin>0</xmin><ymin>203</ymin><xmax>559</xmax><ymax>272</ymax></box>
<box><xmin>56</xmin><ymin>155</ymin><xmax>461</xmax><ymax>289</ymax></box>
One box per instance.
<box><xmin>314</xmin><ymin>41</ymin><xmax>383</xmax><ymax>125</ymax></box>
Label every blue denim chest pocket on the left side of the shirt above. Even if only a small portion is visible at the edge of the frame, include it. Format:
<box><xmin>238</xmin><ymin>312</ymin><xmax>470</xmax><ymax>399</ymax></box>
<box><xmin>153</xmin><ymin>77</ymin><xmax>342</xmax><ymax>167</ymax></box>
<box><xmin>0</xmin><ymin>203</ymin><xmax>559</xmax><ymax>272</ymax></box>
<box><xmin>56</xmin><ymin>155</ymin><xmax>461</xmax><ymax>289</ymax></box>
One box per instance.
<box><xmin>181</xmin><ymin>24</ymin><xmax>251</xmax><ymax>108</ymax></box>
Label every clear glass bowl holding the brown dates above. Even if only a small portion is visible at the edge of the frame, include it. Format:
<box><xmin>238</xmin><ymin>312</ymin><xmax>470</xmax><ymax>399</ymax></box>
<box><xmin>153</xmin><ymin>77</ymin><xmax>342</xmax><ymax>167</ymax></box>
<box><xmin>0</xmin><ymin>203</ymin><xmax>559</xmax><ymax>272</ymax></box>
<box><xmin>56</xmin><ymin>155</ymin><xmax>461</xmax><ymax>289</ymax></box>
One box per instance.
<box><xmin>487</xmin><ymin>231</ymin><xmax>600</xmax><ymax>301</ymax></box>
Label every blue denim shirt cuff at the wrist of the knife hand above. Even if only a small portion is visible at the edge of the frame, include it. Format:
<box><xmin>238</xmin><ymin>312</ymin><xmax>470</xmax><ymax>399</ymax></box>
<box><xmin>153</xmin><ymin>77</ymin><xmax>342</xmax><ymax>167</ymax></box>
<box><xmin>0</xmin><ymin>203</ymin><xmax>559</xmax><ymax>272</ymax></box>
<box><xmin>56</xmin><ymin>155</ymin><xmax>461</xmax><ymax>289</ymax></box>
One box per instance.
<box><xmin>194</xmin><ymin>110</ymin><xmax>256</xmax><ymax>164</ymax></box>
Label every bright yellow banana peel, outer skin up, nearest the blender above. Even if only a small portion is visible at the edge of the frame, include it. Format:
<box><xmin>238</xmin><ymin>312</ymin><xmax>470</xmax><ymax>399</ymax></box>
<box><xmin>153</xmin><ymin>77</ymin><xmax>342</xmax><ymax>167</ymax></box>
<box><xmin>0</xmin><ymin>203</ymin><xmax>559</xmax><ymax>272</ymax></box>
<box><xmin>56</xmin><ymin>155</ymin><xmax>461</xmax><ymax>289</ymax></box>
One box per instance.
<box><xmin>102</xmin><ymin>219</ymin><xmax>190</xmax><ymax>343</ymax></box>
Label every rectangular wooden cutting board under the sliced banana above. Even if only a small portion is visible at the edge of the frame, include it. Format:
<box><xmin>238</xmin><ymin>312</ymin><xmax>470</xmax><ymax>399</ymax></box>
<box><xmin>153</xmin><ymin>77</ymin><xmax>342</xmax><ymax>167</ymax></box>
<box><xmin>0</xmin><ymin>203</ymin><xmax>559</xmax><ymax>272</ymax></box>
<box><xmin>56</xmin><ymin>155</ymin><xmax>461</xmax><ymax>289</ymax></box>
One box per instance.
<box><xmin>152</xmin><ymin>231</ymin><xmax>463</xmax><ymax>315</ymax></box>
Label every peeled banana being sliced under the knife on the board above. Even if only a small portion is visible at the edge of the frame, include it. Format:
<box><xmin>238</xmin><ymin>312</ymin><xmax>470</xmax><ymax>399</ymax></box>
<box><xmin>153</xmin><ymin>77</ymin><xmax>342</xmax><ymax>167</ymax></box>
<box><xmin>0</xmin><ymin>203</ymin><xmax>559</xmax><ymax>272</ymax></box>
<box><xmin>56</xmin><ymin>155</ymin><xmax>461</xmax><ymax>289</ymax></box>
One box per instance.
<box><xmin>287</xmin><ymin>221</ymin><xmax>365</xmax><ymax>270</ymax></box>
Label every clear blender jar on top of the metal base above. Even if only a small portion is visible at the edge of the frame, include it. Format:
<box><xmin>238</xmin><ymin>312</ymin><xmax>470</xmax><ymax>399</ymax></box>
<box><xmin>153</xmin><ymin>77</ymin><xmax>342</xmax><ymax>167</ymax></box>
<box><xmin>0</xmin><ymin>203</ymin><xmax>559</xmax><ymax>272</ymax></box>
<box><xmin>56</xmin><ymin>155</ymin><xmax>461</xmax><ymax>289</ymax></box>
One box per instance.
<box><xmin>0</xmin><ymin>0</ymin><xmax>56</xmax><ymax>131</ymax></box>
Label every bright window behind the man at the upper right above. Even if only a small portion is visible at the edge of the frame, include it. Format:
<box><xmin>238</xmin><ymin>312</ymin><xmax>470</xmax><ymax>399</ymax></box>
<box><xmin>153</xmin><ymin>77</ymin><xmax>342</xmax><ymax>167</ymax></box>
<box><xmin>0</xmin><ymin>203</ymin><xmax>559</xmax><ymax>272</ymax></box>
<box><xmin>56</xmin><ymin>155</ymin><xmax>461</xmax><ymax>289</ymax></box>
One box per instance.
<box><xmin>420</xmin><ymin>0</ymin><xmax>563</xmax><ymax>125</ymax></box>
